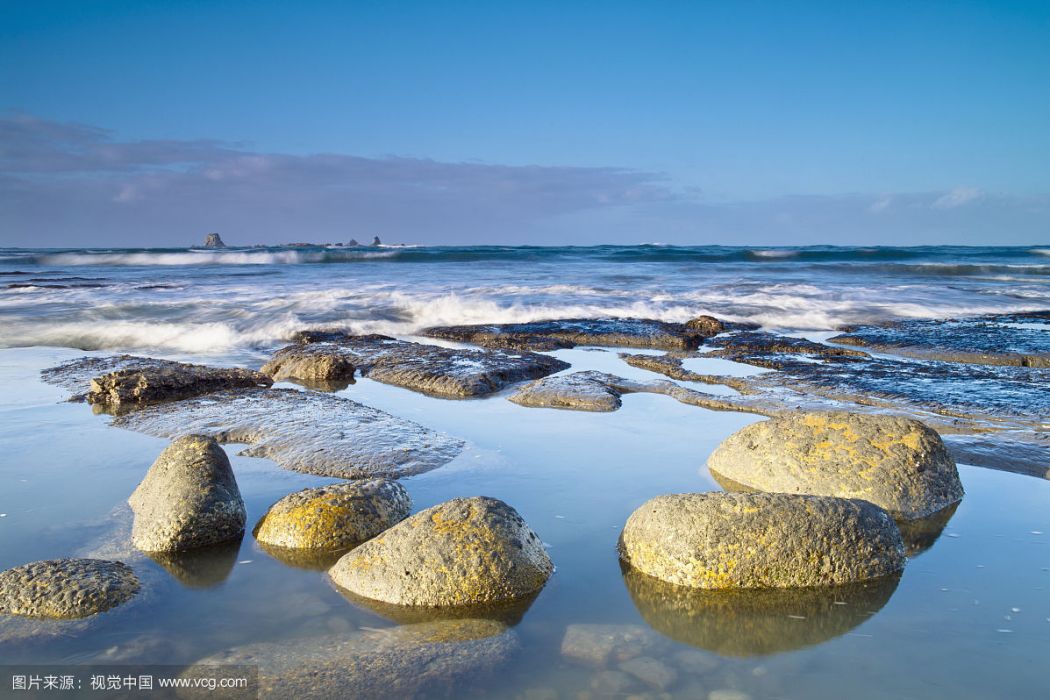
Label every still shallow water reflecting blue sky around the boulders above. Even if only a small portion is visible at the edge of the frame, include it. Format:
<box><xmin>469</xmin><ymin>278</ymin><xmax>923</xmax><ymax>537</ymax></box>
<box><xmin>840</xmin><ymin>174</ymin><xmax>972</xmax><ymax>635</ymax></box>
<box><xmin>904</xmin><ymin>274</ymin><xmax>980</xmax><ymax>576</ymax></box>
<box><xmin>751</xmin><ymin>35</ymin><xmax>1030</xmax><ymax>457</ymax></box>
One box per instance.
<box><xmin>0</xmin><ymin>348</ymin><xmax>1050</xmax><ymax>699</ymax></box>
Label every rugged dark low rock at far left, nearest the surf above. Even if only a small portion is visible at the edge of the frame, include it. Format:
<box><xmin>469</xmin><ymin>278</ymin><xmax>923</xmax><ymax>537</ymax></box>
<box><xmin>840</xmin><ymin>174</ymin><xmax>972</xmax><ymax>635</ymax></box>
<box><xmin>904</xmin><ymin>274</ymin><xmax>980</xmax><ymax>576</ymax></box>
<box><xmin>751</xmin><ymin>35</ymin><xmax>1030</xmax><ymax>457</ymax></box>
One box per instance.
<box><xmin>42</xmin><ymin>355</ymin><xmax>272</xmax><ymax>412</ymax></box>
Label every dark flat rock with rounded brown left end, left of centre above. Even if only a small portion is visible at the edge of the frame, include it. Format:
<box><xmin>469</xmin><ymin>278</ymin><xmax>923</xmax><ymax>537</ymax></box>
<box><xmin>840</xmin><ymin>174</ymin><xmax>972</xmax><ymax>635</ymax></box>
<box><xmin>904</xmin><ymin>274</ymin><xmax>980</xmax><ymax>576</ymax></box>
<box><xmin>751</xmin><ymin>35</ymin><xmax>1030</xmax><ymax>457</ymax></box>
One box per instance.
<box><xmin>263</xmin><ymin>332</ymin><xmax>569</xmax><ymax>399</ymax></box>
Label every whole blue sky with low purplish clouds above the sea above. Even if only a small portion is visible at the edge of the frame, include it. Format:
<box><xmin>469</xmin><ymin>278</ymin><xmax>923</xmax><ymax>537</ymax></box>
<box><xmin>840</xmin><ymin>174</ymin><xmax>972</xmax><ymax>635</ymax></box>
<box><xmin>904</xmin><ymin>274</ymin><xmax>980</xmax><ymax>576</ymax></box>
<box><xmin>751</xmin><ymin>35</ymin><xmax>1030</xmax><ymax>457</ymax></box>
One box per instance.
<box><xmin>0</xmin><ymin>0</ymin><xmax>1050</xmax><ymax>247</ymax></box>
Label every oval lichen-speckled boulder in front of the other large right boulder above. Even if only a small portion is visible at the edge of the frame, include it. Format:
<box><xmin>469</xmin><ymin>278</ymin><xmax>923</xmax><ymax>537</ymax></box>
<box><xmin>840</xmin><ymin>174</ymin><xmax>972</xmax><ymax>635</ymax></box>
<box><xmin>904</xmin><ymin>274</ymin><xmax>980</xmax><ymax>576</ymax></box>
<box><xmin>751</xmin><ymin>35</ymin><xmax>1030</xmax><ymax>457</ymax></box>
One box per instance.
<box><xmin>620</xmin><ymin>491</ymin><xmax>905</xmax><ymax>589</ymax></box>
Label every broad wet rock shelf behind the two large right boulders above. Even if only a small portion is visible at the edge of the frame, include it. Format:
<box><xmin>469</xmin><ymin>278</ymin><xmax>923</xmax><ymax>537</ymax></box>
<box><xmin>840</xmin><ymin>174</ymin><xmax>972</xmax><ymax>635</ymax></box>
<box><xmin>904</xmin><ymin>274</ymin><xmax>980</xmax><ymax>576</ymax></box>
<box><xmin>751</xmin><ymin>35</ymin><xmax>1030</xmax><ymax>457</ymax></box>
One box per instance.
<box><xmin>621</xmin><ymin>333</ymin><xmax>1050</xmax><ymax>478</ymax></box>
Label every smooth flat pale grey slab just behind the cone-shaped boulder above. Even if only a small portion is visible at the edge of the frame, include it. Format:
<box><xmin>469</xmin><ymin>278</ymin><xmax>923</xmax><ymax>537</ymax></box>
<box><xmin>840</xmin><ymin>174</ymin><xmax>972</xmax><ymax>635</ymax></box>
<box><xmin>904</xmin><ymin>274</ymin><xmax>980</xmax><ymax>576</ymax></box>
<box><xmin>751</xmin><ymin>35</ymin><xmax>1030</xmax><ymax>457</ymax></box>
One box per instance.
<box><xmin>113</xmin><ymin>389</ymin><xmax>463</xmax><ymax>479</ymax></box>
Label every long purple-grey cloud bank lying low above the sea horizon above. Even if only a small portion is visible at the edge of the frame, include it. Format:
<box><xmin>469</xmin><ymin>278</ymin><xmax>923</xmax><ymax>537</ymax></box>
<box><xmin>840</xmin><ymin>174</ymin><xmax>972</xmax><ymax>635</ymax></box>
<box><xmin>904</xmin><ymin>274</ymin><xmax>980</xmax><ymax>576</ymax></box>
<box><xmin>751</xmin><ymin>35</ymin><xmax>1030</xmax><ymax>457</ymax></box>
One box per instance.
<box><xmin>0</xmin><ymin>114</ymin><xmax>1050</xmax><ymax>246</ymax></box>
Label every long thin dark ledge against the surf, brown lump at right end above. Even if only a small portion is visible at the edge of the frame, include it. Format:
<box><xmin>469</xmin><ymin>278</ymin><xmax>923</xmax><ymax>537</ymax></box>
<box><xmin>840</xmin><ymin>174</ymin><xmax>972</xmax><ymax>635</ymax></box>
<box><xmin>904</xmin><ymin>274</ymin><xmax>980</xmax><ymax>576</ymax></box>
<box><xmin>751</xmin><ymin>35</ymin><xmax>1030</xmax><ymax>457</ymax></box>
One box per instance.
<box><xmin>421</xmin><ymin>317</ymin><xmax>726</xmax><ymax>351</ymax></box>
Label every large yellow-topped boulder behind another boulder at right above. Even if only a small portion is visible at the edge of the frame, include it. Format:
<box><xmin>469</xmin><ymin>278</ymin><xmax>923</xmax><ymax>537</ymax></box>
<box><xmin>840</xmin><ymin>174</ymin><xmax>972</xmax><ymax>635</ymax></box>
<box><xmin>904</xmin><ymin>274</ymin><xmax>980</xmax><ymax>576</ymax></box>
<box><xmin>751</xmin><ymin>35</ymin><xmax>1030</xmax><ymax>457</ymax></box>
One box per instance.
<box><xmin>708</xmin><ymin>411</ymin><xmax>963</xmax><ymax>518</ymax></box>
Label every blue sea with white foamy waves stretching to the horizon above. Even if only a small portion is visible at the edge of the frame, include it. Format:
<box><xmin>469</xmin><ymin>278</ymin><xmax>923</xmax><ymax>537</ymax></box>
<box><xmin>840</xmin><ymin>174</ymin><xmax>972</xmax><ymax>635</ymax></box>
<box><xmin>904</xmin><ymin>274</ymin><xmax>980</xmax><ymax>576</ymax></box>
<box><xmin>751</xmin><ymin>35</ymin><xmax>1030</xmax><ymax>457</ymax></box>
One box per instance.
<box><xmin>0</xmin><ymin>246</ymin><xmax>1050</xmax><ymax>356</ymax></box>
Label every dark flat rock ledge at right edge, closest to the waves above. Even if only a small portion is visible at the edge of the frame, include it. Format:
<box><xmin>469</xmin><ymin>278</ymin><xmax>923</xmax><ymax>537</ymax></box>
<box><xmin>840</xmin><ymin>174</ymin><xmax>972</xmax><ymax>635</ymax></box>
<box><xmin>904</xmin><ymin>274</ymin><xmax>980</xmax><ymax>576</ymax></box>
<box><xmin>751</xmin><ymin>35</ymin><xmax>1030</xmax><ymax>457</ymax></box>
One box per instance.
<box><xmin>831</xmin><ymin>311</ymin><xmax>1050</xmax><ymax>367</ymax></box>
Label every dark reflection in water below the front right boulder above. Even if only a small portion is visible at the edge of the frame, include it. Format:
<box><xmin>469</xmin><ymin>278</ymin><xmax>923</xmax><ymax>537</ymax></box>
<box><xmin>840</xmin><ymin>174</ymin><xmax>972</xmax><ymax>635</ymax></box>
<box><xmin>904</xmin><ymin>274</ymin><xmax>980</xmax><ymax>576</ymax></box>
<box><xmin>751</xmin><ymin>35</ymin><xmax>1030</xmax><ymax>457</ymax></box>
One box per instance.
<box><xmin>624</xmin><ymin>566</ymin><xmax>900</xmax><ymax>656</ymax></box>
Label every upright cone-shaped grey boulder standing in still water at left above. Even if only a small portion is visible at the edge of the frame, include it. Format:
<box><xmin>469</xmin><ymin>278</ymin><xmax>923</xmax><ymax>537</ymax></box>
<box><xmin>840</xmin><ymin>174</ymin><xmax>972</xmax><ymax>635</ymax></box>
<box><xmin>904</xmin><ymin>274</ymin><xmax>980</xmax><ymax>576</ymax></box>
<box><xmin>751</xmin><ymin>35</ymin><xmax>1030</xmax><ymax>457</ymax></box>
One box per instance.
<box><xmin>128</xmin><ymin>434</ymin><xmax>247</xmax><ymax>552</ymax></box>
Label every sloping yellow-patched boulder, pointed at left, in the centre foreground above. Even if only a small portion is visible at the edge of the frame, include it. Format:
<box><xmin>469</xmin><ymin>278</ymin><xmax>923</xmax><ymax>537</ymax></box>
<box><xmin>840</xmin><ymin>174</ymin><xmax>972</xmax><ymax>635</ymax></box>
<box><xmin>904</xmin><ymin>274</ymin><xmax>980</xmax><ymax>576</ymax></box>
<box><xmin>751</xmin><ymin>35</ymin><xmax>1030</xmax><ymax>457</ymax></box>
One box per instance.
<box><xmin>329</xmin><ymin>496</ymin><xmax>553</xmax><ymax>607</ymax></box>
